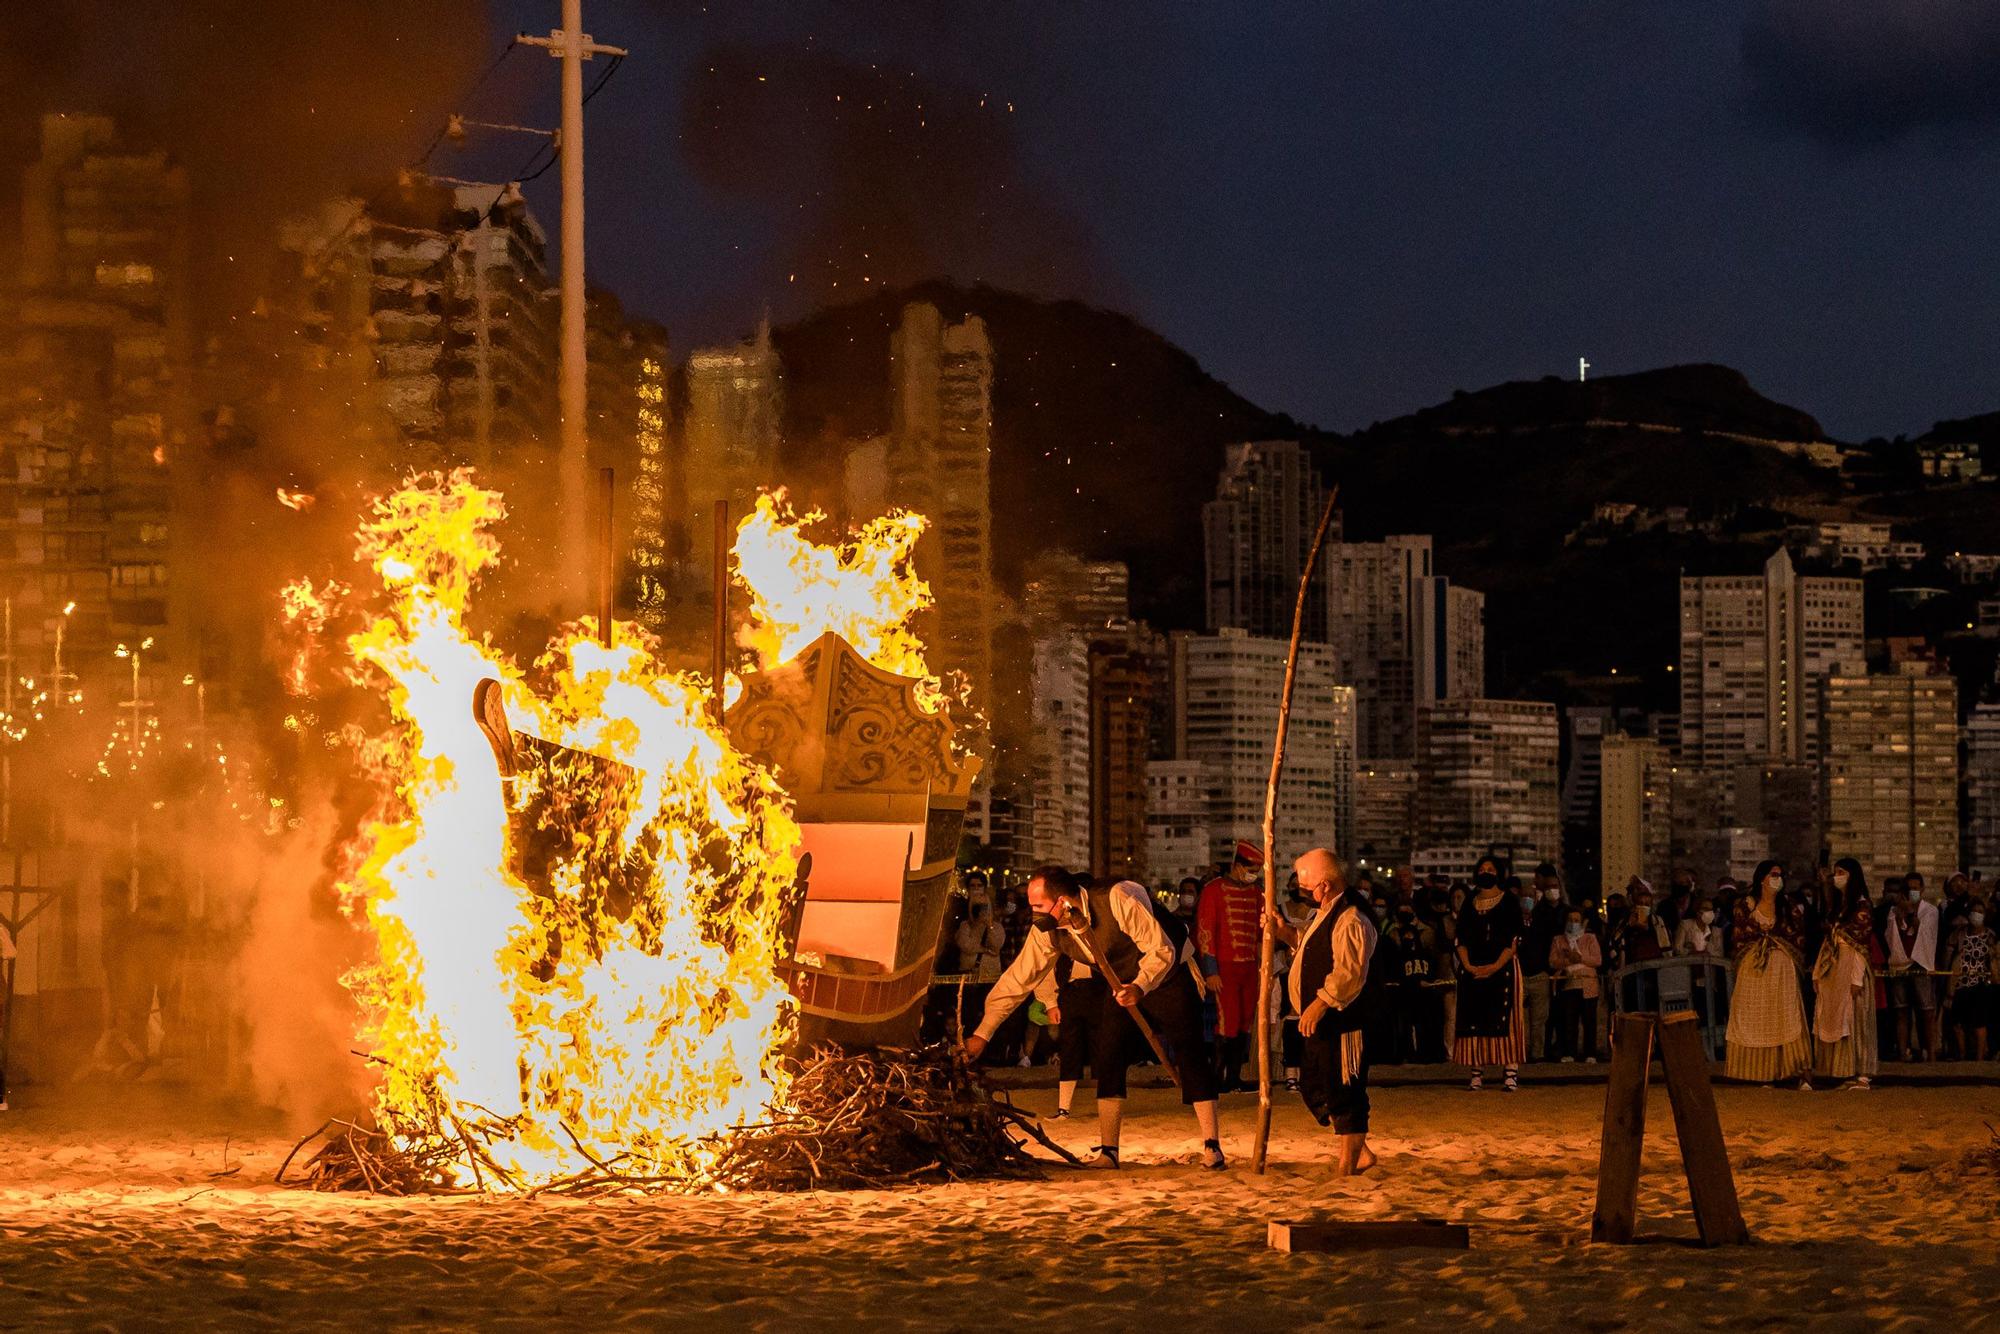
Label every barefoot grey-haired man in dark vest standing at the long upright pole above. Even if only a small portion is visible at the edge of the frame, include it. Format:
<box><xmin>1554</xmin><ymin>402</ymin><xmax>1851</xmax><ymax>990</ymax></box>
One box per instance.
<box><xmin>1272</xmin><ymin>848</ymin><xmax>1376</xmax><ymax>1176</ymax></box>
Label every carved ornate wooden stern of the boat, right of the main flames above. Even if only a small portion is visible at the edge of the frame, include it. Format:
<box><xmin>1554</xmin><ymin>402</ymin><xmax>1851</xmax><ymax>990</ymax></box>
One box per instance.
<box><xmin>724</xmin><ymin>632</ymin><xmax>980</xmax><ymax>1046</ymax></box>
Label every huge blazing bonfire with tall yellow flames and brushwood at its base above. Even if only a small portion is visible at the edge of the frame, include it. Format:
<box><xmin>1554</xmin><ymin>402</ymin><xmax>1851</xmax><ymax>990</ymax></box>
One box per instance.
<box><xmin>280</xmin><ymin>470</ymin><xmax>1032</xmax><ymax>1192</ymax></box>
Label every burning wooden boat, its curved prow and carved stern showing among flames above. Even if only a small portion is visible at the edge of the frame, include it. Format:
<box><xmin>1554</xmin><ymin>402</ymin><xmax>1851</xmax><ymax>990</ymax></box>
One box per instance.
<box><xmin>472</xmin><ymin>632</ymin><xmax>980</xmax><ymax>1046</ymax></box>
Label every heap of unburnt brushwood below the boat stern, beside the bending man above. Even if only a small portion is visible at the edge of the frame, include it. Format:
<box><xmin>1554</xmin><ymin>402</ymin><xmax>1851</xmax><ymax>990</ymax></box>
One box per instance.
<box><xmin>708</xmin><ymin>1044</ymin><xmax>1076</xmax><ymax>1190</ymax></box>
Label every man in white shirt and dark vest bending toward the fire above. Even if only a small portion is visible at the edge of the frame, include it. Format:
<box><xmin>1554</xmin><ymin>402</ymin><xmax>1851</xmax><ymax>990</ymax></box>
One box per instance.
<box><xmin>966</xmin><ymin>866</ymin><xmax>1224</xmax><ymax>1168</ymax></box>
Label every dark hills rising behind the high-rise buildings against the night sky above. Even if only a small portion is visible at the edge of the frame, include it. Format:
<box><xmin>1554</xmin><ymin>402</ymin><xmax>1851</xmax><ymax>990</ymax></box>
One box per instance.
<box><xmin>774</xmin><ymin>282</ymin><xmax>1982</xmax><ymax>702</ymax></box>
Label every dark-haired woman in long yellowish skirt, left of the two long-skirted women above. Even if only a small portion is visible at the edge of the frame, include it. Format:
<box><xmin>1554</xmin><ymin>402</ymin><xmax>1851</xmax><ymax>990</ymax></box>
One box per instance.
<box><xmin>1724</xmin><ymin>862</ymin><xmax>1812</xmax><ymax>1090</ymax></box>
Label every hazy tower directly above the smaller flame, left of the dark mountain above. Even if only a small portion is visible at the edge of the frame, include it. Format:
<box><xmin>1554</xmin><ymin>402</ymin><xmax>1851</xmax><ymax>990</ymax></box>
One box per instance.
<box><xmin>674</xmin><ymin>320</ymin><xmax>784</xmax><ymax>574</ymax></box>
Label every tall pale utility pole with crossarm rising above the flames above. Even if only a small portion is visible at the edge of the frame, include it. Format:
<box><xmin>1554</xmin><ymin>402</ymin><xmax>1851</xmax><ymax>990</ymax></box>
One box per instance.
<box><xmin>520</xmin><ymin>0</ymin><xmax>626</xmax><ymax>588</ymax></box>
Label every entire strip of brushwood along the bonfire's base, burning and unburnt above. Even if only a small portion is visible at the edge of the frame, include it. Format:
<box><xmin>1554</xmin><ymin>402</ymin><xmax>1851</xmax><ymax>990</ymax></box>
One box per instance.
<box><xmin>276</xmin><ymin>1044</ymin><xmax>1076</xmax><ymax>1196</ymax></box>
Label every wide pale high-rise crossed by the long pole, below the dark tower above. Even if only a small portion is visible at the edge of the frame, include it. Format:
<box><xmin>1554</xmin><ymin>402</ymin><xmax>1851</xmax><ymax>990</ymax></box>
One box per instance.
<box><xmin>1174</xmin><ymin>630</ymin><xmax>1338</xmax><ymax>862</ymax></box>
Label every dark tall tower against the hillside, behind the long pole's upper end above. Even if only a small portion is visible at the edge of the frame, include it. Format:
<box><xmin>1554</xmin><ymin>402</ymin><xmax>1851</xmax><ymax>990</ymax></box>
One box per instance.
<box><xmin>1202</xmin><ymin>440</ymin><xmax>1340</xmax><ymax>642</ymax></box>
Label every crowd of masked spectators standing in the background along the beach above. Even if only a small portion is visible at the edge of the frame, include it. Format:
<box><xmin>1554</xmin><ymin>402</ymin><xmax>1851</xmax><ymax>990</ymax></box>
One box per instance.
<box><xmin>932</xmin><ymin>862</ymin><xmax>2000</xmax><ymax>1088</ymax></box>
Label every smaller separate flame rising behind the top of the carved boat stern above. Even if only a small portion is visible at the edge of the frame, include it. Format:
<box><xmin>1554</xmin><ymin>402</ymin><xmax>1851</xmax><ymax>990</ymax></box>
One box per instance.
<box><xmin>734</xmin><ymin>492</ymin><xmax>944</xmax><ymax>710</ymax></box>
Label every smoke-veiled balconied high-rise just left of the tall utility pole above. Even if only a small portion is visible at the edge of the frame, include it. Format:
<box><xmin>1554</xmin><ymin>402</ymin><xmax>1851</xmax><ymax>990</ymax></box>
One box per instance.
<box><xmin>278</xmin><ymin>176</ymin><xmax>556</xmax><ymax>468</ymax></box>
